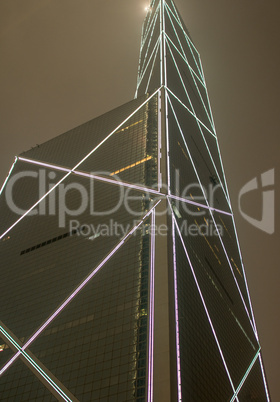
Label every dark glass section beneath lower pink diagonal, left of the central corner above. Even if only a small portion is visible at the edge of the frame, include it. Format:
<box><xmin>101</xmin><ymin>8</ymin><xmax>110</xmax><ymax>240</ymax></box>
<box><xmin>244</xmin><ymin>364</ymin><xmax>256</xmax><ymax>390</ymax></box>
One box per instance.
<box><xmin>30</xmin><ymin>222</ymin><xmax>150</xmax><ymax>401</ymax></box>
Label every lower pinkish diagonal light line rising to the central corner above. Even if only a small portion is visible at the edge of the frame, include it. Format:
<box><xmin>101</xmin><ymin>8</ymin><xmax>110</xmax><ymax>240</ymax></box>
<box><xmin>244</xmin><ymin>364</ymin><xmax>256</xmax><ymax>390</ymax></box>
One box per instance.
<box><xmin>0</xmin><ymin>200</ymin><xmax>161</xmax><ymax>377</ymax></box>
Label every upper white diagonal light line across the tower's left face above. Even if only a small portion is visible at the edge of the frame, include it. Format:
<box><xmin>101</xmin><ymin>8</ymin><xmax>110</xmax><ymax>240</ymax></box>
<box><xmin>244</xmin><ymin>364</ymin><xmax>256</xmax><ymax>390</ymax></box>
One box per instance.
<box><xmin>0</xmin><ymin>88</ymin><xmax>160</xmax><ymax>240</ymax></box>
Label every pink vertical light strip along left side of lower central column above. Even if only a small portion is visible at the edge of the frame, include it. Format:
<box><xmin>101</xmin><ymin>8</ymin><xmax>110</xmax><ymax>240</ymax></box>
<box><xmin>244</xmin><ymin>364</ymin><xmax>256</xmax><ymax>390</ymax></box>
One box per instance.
<box><xmin>148</xmin><ymin>210</ymin><xmax>155</xmax><ymax>402</ymax></box>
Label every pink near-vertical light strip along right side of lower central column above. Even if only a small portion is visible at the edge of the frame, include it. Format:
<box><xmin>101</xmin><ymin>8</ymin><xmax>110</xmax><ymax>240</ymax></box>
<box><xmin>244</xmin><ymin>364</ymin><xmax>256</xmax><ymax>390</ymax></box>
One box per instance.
<box><xmin>168</xmin><ymin>200</ymin><xmax>182</xmax><ymax>402</ymax></box>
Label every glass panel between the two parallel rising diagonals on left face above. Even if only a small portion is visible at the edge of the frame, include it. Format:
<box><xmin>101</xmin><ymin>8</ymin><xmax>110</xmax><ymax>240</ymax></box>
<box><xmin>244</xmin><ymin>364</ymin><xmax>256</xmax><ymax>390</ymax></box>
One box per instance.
<box><xmin>0</xmin><ymin>176</ymin><xmax>158</xmax><ymax>341</ymax></box>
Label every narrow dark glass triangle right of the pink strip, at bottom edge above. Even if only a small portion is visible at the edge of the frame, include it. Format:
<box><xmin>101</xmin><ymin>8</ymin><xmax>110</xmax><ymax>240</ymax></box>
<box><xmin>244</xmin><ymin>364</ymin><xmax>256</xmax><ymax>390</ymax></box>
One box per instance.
<box><xmin>176</xmin><ymin>228</ymin><xmax>233</xmax><ymax>402</ymax></box>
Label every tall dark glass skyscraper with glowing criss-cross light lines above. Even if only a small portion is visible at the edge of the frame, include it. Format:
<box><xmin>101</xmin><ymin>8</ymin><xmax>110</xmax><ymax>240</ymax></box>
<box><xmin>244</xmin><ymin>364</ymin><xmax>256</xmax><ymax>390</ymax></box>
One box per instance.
<box><xmin>0</xmin><ymin>0</ymin><xmax>269</xmax><ymax>401</ymax></box>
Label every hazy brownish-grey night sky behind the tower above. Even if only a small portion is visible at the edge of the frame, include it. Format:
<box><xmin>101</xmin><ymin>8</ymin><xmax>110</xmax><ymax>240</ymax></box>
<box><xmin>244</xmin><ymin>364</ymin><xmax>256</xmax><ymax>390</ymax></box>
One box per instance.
<box><xmin>0</xmin><ymin>0</ymin><xmax>280</xmax><ymax>401</ymax></box>
